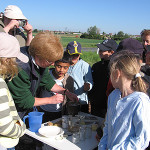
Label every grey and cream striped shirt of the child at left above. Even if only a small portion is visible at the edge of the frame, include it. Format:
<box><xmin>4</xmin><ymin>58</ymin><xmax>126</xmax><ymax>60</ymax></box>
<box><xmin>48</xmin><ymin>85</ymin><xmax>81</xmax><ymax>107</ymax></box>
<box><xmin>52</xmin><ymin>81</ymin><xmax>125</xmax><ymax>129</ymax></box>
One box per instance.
<box><xmin>0</xmin><ymin>76</ymin><xmax>26</xmax><ymax>148</ymax></box>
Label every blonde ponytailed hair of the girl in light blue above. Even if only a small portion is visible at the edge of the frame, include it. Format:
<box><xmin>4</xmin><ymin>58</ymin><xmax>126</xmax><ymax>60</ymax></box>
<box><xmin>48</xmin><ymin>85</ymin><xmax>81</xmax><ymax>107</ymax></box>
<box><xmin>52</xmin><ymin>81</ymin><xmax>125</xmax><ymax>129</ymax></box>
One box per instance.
<box><xmin>109</xmin><ymin>50</ymin><xmax>147</xmax><ymax>93</ymax></box>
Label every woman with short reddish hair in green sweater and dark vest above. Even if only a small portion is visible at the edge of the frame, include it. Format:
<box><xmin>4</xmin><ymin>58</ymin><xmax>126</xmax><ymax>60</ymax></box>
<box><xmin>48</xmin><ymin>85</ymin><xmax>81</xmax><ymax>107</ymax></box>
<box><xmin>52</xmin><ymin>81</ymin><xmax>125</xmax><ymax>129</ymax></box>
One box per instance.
<box><xmin>7</xmin><ymin>32</ymin><xmax>78</xmax><ymax>118</ymax></box>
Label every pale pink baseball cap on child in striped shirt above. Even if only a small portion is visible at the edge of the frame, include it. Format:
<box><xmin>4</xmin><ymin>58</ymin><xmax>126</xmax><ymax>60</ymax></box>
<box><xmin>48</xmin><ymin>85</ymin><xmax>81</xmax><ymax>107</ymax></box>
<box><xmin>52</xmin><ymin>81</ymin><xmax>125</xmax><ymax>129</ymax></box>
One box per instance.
<box><xmin>0</xmin><ymin>32</ymin><xmax>29</xmax><ymax>63</ymax></box>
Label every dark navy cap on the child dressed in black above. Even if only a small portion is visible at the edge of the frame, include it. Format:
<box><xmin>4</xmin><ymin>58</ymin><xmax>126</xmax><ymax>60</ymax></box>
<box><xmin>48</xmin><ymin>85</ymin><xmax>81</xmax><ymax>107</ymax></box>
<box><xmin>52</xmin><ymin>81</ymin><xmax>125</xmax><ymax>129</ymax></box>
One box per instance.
<box><xmin>97</xmin><ymin>39</ymin><xmax>118</xmax><ymax>54</ymax></box>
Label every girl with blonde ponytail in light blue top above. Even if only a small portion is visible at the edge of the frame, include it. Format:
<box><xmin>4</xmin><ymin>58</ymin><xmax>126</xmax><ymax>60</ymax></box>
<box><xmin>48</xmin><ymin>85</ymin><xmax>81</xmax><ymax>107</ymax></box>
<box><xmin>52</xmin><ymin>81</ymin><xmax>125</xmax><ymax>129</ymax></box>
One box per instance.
<box><xmin>98</xmin><ymin>51</ymin><xmax>150</xmax><ymax>150</ymax></box>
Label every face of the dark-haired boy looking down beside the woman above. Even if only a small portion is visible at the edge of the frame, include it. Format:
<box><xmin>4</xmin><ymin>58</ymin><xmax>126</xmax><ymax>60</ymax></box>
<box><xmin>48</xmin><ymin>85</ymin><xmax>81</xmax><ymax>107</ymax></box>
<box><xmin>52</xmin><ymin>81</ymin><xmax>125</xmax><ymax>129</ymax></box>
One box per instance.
<box><xmin>55</xmin><ymin>62</ymin><xmax>70</xmax><ymax>78</ymax></box>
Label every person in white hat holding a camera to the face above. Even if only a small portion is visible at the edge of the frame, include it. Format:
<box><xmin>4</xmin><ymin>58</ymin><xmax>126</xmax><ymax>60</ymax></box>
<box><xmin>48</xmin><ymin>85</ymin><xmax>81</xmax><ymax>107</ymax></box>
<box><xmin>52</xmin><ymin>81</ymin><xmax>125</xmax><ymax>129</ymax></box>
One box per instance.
<box><xmin>0</xmin><ymin>5</ymin><xmax>32</xmax><ymax>47</ymax></box>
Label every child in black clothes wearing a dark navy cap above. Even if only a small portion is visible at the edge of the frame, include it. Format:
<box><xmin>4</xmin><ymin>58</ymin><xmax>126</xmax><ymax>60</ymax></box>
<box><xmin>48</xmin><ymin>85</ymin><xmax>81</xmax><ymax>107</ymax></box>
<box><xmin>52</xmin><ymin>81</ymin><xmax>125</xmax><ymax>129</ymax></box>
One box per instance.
<box><xmin>89</xmin><ymin>39</ymin><xmax>118</xmax><ymax>118</ymax></box>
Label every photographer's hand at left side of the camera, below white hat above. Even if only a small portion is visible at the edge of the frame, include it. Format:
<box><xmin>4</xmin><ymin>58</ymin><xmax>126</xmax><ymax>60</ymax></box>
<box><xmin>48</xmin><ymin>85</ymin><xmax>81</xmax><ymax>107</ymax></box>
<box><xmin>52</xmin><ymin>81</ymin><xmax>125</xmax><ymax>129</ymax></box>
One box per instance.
<box><xmin>4</xmin><ymin>19</ymin><xmax>19</xmax><ymax>33</ymax></box>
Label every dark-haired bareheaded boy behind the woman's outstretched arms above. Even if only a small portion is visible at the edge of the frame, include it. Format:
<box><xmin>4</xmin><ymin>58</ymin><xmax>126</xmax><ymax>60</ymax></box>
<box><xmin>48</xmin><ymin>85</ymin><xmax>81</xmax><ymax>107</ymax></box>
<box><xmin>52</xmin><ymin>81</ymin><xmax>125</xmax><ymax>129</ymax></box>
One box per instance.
<box><xmin>39</xmin><ymin>52</ymin><xmax>74</xmax><ymax>122</ymax></box>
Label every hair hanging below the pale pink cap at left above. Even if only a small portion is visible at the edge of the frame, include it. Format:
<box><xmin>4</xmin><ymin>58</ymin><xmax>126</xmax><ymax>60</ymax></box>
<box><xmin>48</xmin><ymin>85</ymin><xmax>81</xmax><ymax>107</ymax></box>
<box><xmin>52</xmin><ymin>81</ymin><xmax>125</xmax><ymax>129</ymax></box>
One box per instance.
<box><xmin>0</xmin><ymin>57</ymin><xmax>18</xmax><ymax>80</ymax></box>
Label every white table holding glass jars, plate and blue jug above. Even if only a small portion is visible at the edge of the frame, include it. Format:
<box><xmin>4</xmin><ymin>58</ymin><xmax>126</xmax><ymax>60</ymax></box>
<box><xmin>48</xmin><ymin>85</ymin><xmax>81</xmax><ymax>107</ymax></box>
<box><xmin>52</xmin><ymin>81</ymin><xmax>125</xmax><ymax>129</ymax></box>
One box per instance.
<box><xmin>26</xmin><ymin>114</ymin><xmax>104</xmax><ymax>150</ymax></box>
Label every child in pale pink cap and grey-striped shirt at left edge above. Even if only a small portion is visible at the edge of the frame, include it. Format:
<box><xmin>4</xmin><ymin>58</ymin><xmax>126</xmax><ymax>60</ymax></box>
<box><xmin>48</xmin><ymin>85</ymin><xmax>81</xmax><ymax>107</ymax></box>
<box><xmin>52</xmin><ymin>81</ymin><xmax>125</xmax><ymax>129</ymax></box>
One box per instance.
<box><xmin>0</xmin><ymin>32</ymin><xmax>28</xmax><ymax>150</ymax></box>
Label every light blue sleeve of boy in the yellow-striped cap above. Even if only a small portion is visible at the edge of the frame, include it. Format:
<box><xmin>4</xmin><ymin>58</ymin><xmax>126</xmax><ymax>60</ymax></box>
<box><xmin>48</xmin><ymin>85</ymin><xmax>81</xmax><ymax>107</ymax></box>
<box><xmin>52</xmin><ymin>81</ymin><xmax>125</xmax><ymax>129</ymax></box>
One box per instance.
<box><xmin>84</xmin><ymin>63</ymin><xmax>93</xmax><ymax>91</ymax></box>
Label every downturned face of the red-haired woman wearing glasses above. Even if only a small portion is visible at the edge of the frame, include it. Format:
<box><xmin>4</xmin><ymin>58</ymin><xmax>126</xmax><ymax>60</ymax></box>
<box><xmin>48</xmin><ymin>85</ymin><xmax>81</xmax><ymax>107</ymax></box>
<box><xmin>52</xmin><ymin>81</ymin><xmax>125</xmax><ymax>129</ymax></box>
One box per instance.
<box><xmin>35</xmin><ymin>56</ymin><xmax>54</xmax><ymax>68</ymax></box>
